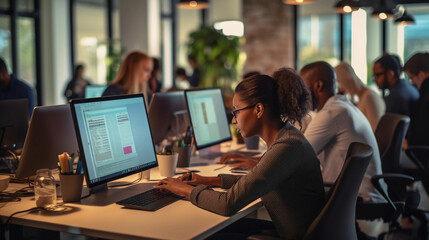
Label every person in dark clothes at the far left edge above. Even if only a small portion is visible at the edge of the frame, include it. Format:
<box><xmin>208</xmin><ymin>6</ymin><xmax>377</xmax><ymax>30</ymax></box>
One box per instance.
<box><xmin>0</xmin><ymin>58</ymin><xmax>37</xmax><ymax>117</ymax></box>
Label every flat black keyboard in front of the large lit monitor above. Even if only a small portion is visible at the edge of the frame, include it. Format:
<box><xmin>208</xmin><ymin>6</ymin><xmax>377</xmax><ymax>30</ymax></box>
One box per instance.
<box><xmin>116</xmin><ymin>188</ymin><xmax>183</xmax><ymax>211</ymax></box>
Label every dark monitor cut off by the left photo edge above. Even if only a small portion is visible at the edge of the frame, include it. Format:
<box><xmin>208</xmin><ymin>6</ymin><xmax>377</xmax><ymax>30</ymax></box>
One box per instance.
<box><xmin>0</xmin><ymin>98</ymin><xmax>28</xmax><ymax>150</ymax></box>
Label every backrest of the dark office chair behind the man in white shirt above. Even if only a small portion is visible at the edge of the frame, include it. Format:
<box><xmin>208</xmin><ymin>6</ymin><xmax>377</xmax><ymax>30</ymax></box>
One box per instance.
<box><xmin>375</xmin><ymin>113</ymin><xmax>410</xmax><ymax>173</ymax></box>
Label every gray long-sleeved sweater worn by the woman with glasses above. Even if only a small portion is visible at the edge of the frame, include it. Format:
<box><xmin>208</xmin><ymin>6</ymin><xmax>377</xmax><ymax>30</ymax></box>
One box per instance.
<box><xmin>191</xmin><ymin>123</ymin><xmax>325</xmax><ymax>239</ymax></box>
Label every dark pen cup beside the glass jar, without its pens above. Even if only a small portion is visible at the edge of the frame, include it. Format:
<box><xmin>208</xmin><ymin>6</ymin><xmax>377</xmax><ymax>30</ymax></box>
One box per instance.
<box><xmin>60</xmin><ymin>174</ymin><xmax>83</xmax><ymax>202</ymax></box>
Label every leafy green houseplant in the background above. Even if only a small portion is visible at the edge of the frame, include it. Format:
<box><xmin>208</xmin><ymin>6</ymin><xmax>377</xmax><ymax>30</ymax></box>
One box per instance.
<box><xmin>187</xmin><ymin>26</ymin><xmax>241</xmax><ymax>92</ymax></box>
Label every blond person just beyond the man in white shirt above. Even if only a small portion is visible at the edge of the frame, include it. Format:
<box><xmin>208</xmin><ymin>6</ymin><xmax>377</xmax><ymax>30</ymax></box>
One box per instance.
<box><xmin>335</xmin><ymin>62</ymin><xmax>386</xmax><ymax>131</ymax></box>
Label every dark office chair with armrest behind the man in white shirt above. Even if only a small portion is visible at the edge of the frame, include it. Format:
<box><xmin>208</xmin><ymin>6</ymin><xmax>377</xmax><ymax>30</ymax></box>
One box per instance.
<box><xmin>356</xmin><ymin>113</ymin><xmax>413</xmax><ymax>224</ymax></box>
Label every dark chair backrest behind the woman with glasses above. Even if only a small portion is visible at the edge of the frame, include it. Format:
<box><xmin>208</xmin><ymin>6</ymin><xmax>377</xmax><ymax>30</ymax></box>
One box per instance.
<box><xmin>304</xmin><ymin>142</ymin><xmax>373</xmax><ymax>240</ymax></box>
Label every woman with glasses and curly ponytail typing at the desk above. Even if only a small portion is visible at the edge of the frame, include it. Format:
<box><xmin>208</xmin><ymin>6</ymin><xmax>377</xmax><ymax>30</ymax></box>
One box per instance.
<box><xmin>156</xmin><ymin>69</ymin><xmax>325</xmax><ymax>239</ymax></box>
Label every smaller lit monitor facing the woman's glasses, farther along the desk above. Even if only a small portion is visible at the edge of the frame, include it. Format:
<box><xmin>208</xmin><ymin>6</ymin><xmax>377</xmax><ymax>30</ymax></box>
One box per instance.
<box><xmin>185</xmin><ymin>88</ymin><xmax>232</xmax><ymax>149</ymax></box>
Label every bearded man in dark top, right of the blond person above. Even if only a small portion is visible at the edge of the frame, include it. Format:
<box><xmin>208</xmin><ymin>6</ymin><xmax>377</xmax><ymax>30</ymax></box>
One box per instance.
<box><xmin>373</xmin><ymin>54</ymin><xmax>419</xmax><ymax>116</ymax></box>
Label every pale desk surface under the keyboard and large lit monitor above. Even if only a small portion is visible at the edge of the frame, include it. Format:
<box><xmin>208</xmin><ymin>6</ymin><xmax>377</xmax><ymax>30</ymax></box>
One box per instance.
<box><xmin>0</xmin><ymin>142</ymin><xmax>262</xmax><ymax>239</ymax></box>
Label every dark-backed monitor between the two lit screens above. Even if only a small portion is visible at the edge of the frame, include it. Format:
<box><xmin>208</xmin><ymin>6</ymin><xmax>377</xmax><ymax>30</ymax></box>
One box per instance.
<box><xmin>148</xmin><ymin>91</ymin><xmax>190</xmax><ymax>144</ymax></box>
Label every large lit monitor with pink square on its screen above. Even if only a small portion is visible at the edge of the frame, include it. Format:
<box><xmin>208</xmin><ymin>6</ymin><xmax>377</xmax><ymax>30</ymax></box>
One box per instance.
<box><xmin>70</xmin><ymin>94</ymin><xmax>158</xmax><ymax>192</ymax></box>
